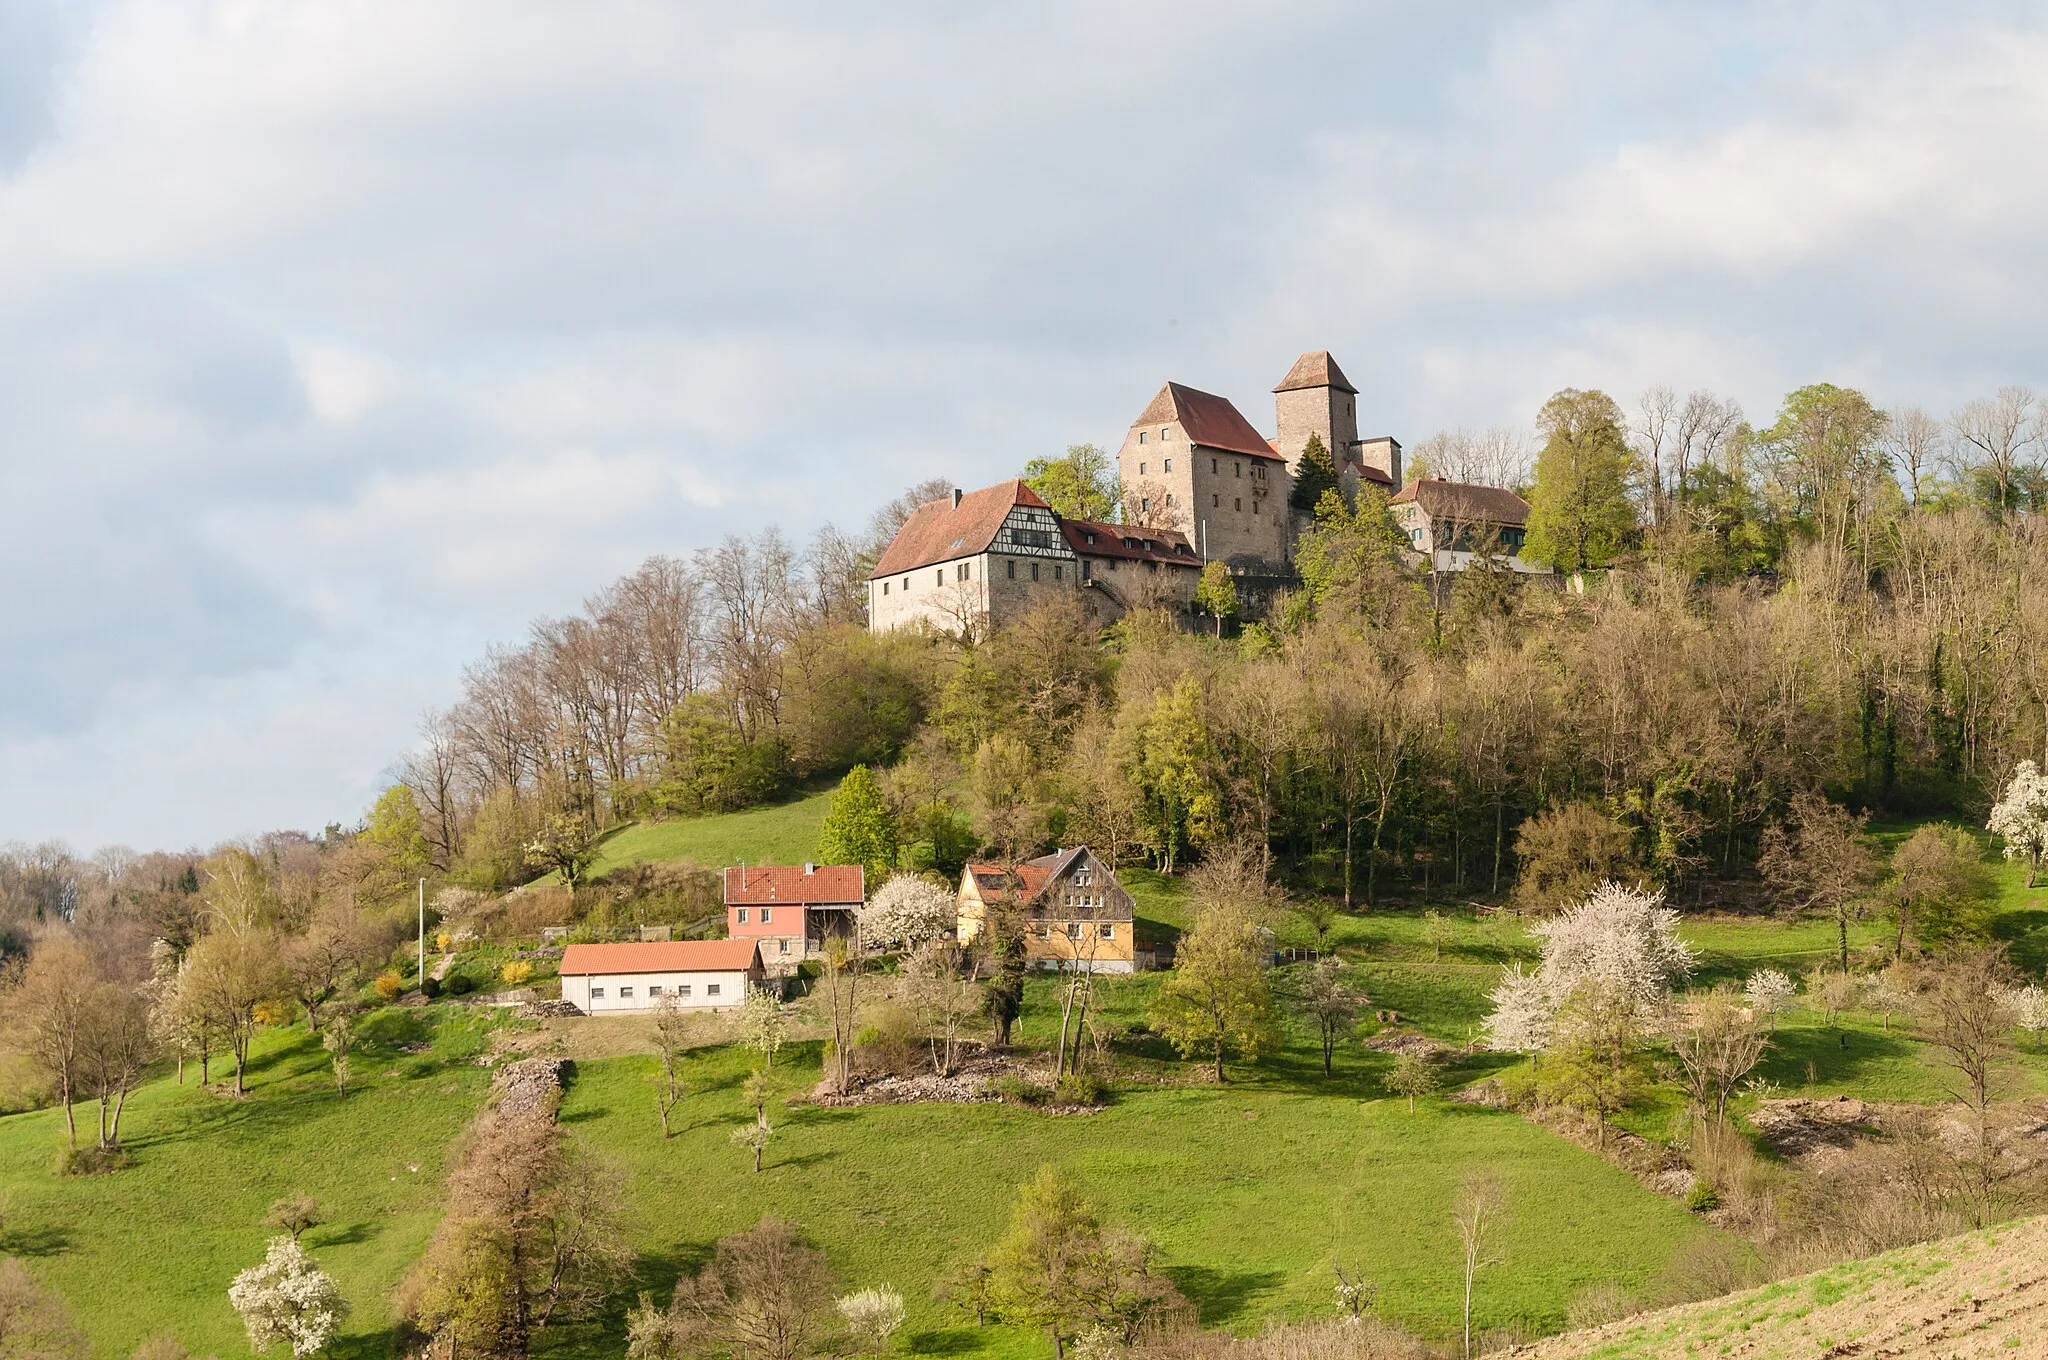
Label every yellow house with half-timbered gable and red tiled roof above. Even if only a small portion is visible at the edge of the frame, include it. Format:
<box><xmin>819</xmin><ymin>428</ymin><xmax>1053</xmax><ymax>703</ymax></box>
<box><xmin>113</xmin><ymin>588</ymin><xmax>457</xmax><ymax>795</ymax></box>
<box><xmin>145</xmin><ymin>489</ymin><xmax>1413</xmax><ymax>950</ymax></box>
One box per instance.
<box><xmin>958</xmin><ymin>846</ymin><xmax>1137</xmax><ymax>973</ymax></box>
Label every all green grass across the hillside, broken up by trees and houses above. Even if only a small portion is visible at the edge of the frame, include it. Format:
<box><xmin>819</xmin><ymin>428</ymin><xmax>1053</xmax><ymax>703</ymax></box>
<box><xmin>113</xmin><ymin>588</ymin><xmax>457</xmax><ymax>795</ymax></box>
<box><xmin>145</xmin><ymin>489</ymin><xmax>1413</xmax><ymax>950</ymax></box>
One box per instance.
<box><xmin>0</xmin><ymin>811</ymin><xmax>2048</xmax><ymax>1360</ymax></box>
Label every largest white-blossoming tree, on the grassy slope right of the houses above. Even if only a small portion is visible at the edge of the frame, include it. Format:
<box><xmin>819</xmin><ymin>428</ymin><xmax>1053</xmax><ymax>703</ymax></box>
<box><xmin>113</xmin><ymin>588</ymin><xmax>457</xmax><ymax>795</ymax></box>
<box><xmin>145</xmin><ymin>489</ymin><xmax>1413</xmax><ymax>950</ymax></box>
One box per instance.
<box><xmin>1487</xmin><ymin>883</ymin><xmax>1692</xmax><ymax>1053</ymax></box>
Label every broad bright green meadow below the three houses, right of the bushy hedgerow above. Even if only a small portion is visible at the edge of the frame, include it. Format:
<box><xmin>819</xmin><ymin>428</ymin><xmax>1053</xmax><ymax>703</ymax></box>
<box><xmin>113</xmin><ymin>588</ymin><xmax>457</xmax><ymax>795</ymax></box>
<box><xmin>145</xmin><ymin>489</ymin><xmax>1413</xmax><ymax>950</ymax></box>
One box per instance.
<box><xmin>536</xmin><ymin>1036</ymin><xmax>1706</xmax><ymax>1356</ymax></box>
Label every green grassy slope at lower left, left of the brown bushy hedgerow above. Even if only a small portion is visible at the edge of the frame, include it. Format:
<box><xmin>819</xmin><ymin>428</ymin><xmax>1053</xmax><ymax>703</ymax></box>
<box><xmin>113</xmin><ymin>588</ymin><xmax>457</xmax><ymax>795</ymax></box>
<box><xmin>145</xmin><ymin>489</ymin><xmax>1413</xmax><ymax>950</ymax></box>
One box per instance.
<box><xmin>0</xmin><ymin>1008</ymin><xmax>489</xmax><ymax>1358</ymax></box>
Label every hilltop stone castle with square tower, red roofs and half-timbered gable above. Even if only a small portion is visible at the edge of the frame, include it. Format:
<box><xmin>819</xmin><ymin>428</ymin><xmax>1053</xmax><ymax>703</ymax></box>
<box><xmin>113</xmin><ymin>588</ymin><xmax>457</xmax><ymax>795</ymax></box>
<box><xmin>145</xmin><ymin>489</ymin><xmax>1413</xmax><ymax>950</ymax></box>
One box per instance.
<box><xmin>868</xmin><ymin>350</ymin><xmax>1526</xmax><ymax>631</ymax></box>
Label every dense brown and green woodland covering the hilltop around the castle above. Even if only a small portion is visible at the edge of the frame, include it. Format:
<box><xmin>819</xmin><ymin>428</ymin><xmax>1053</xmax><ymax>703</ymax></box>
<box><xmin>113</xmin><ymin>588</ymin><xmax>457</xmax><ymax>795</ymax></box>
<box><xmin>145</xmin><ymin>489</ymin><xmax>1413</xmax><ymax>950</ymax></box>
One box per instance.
<box><xmin>0</xmin><ymin>385</ymin><xmax>2048</xmax><ymax>940</ymax></box>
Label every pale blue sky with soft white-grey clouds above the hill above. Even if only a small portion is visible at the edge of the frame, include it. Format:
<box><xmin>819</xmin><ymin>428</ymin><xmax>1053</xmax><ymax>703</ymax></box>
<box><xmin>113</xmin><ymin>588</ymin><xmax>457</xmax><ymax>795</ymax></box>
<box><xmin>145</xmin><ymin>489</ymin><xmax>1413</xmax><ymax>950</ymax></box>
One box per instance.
<box><xmin>0</xmin><ymin>0</ymin><xmax>2048</xmax><ymax>848</ymax></box>
